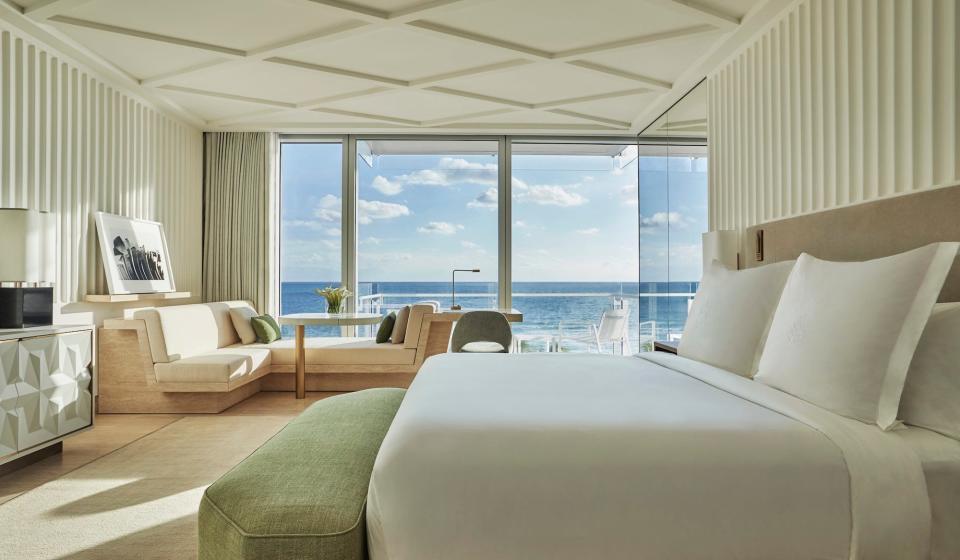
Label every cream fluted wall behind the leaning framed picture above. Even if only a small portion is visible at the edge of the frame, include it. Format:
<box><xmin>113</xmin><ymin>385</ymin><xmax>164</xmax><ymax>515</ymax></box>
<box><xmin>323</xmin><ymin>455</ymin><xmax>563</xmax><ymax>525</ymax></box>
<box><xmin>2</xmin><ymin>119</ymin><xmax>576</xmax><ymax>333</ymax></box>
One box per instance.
<box><xmin>0</xmin><ymin>25</ymin><xmax>203</xmax><ymax>303</ymax></box>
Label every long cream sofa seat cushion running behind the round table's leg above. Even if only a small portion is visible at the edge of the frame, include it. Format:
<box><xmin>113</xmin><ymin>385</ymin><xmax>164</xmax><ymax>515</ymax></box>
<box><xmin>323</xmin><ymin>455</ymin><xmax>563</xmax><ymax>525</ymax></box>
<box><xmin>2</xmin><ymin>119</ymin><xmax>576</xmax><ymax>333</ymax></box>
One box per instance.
<box><xmin>246</xmin><ymin>336</ymin><xmax>417</xmax><ymax>365</ymax></box>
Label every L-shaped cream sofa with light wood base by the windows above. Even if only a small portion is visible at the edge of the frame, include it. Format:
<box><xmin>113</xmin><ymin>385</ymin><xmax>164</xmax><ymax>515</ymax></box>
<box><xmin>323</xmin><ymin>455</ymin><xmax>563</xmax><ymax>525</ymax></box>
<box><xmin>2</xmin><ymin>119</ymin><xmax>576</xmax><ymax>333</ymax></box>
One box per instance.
<box><xmin>98</xmin><ymin>301</ymin><xmax>452</xmax><ymax>413</ymax></box>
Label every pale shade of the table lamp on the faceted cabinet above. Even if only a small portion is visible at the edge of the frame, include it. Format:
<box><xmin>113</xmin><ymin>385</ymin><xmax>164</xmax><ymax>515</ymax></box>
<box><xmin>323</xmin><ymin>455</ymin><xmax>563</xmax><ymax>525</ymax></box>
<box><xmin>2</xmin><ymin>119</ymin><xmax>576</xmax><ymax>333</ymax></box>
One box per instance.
<box><xmin>0</xmin><ymin>208</ymin><xmax>56</xmax><ymax>283</ymax></box>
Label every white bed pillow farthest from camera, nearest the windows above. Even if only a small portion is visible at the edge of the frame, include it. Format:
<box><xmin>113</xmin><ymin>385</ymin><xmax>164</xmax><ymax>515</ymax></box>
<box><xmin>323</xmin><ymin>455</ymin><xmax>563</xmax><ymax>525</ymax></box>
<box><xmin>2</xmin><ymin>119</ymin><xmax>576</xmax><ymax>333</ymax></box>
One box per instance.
<box><xmin>677</xmin><ymin>261</ymin><xmax>796</xmax><ymax>377</ymax></box>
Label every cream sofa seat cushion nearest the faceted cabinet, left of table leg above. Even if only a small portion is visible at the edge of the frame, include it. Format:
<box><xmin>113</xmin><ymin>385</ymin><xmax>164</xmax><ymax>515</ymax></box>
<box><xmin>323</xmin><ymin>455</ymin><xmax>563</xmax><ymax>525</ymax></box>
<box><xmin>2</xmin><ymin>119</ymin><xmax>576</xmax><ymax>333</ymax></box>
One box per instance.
<box><xmin>154</xmin><ymin>346</ymin><xmax>272</xmax><ymax>383</ymax></box>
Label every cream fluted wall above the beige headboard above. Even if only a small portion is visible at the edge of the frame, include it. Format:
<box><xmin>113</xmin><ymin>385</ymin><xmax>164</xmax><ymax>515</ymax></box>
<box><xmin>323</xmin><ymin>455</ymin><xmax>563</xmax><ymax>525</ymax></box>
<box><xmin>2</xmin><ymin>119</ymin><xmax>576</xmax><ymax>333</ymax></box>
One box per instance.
<box><xmin>708</xmin><ymin>0</ymin><xmax>960</xmax><ymax>229</ymax></box>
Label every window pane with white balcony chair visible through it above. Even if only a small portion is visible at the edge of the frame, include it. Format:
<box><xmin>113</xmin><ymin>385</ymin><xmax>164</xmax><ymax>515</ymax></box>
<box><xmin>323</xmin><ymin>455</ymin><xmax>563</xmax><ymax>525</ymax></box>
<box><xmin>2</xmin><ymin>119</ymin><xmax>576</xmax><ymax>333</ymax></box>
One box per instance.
<box><xmin>512</xmin><ymin>142</ymin><xmax>651</xmax><ymax>351</ymax></box>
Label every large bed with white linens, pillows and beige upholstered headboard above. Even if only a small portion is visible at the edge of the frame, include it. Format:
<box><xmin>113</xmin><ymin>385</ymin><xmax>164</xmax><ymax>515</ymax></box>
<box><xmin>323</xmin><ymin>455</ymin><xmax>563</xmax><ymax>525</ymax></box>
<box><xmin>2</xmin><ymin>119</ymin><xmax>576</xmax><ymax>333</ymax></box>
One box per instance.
<box><xmin>367</xmin><ymin>187</ymin><xmax>960</xmax><ymax>560</ymax></box>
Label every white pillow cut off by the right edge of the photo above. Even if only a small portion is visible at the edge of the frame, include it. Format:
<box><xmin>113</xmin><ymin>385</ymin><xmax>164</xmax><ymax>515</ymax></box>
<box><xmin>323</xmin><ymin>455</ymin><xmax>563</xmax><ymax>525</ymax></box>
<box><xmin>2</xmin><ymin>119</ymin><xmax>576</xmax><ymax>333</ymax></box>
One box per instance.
<box><xmin>900</xmin><ymin>303</ymin><xmax>960</xmax><ymax>440</ymax></box>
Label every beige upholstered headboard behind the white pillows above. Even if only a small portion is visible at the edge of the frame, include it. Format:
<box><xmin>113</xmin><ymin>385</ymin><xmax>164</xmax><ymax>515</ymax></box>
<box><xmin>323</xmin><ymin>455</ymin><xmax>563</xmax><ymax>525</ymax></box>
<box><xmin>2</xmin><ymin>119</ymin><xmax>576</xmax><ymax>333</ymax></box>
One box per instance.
<box><xmin>741</xmin><ymin>186</ymin><xmax>960</xmax><ymax>301</ymax></box>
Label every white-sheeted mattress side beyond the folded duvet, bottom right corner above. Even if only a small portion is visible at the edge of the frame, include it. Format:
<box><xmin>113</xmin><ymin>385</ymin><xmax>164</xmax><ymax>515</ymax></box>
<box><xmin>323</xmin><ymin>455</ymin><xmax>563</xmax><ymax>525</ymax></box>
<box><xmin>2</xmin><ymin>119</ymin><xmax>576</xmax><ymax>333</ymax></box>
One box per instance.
<box><xmin>894</xmin><ymin>427</ymin><xmax>960</xmax><ymax>560</ymax></box>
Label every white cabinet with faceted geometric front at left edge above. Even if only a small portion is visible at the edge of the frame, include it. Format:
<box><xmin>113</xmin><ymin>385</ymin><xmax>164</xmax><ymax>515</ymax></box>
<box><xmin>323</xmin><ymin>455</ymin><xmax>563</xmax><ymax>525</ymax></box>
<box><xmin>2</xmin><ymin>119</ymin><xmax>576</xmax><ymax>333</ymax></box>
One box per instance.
<box><xmin>0</xmin><ymin>329</ymin><xmax>93</xmax><ymax>462</ymax></box>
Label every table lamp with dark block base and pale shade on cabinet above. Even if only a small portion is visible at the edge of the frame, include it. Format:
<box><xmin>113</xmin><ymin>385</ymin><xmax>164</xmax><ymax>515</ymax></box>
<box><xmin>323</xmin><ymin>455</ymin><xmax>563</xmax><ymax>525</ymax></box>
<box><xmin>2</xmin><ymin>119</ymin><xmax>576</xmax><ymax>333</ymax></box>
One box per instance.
<box><xmin>0</xmin><ymin>208</ymin><xmax>56</xmax><ymax>329</ymax></box>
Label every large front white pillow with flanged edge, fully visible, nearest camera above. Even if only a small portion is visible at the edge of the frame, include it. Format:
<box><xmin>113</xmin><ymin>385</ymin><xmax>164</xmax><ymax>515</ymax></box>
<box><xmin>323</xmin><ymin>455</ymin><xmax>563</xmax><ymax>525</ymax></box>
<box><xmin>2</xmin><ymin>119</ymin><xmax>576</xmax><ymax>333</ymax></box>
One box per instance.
<box><xmin>756</xmin><ymin>243</ymin><xmax>960</xmax><ymax>430</ymax></box>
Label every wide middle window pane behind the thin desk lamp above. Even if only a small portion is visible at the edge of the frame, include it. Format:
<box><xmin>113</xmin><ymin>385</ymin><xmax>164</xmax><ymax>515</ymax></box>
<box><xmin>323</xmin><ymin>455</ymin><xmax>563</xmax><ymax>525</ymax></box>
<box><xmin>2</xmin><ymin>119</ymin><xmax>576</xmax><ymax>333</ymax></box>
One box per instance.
<box><xmin>356</xmin><ymin>139</ymin><xmax>499</xmax><ymax>318</ymax></box>
